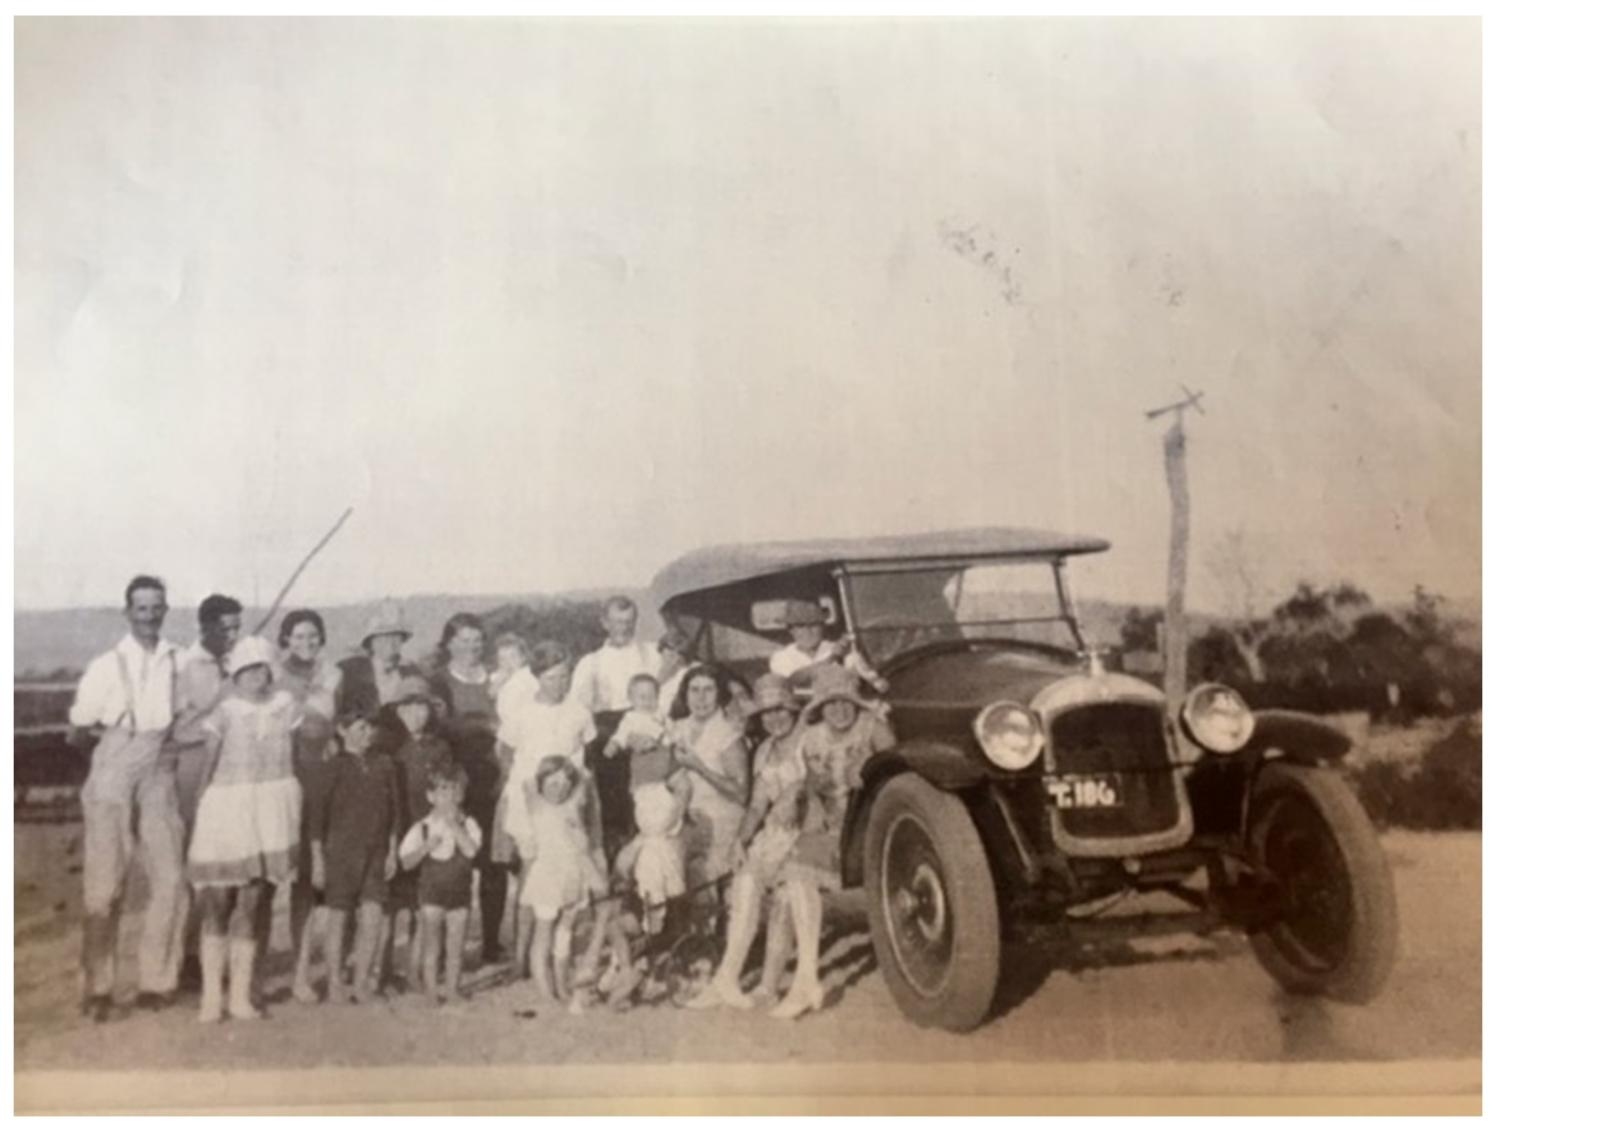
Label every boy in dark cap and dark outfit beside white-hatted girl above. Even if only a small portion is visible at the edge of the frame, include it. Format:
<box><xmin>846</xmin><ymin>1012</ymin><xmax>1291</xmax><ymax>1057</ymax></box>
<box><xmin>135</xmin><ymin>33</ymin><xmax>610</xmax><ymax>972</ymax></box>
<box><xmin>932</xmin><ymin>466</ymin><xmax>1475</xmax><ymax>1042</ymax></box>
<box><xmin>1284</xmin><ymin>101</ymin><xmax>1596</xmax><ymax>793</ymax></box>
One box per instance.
<box><xmin>306</xmin><ymin>710</ymin><xmax>400</xmax><ymax>1001</ymax></box>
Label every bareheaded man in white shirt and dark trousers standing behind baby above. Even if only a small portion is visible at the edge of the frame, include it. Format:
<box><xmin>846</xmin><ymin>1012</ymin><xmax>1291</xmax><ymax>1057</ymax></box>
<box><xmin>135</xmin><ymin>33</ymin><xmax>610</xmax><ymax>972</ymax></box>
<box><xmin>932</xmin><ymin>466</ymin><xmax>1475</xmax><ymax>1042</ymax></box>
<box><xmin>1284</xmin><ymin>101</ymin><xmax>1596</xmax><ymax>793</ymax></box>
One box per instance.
<box><xmin>566</xmin><ymin>597</ymin><xmax>669</xmax><ymax>862</ymax></box>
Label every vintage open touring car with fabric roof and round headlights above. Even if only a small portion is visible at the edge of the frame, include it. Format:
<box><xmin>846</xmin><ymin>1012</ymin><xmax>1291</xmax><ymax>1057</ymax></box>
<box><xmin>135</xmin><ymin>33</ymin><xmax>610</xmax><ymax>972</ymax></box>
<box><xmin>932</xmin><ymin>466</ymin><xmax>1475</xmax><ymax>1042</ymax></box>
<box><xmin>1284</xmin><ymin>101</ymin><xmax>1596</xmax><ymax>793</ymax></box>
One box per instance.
<box><xmin>653</xmin><ymin>528</ymin><xmax>1397</xmax><ymax>1030</ymax></box>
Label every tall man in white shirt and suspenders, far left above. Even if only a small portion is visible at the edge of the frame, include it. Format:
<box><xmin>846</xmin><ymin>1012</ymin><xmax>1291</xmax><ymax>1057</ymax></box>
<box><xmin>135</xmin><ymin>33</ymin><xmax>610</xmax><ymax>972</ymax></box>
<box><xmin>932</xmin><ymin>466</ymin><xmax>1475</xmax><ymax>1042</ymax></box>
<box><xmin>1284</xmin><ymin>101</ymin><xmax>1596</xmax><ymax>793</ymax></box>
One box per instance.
<box><xmin>69</xmin><ymin>574</ymin><xmax>184</xmax><ymax>1022</ymax></box>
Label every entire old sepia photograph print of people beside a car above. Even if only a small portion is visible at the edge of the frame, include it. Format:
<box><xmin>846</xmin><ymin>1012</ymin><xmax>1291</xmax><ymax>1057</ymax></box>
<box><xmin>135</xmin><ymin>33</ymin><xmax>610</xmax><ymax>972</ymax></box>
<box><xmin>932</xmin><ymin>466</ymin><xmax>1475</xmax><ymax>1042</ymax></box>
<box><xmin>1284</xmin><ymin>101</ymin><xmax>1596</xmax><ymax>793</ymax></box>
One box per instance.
<box><xmin>11</xmin><ymin>18</ymin><xmax>1483</xmax><ymax>1115</ymax></box>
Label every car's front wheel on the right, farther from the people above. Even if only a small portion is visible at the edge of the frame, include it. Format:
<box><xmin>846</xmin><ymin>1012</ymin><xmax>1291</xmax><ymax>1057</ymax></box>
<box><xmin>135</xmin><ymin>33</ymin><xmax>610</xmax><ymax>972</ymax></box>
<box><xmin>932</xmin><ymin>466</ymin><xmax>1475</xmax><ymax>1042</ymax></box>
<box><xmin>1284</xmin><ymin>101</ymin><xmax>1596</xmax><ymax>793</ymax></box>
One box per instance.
<box><xmin>1250</xmin><ymin>763</ymin><xmax>1400</xmax><ymax>1005</ymax></box>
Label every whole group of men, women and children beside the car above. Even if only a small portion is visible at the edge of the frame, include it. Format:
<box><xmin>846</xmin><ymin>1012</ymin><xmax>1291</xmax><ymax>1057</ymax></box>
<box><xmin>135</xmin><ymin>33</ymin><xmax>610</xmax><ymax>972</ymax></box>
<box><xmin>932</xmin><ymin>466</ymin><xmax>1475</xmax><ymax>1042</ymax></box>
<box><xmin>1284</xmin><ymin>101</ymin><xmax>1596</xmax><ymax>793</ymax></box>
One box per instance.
<box><xmin>70</xmin><ymin>576</ymin><xmax>894</xmax><ymax>1022</ymax></box>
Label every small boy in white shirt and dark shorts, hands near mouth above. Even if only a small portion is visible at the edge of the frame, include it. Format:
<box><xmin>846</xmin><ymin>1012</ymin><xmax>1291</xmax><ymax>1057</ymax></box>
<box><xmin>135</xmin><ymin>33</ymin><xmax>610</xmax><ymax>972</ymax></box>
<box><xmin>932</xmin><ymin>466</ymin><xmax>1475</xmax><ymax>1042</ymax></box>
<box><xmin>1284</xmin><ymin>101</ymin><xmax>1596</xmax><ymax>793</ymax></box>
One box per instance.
<box><xmin>400</xmin><ymin>761</ymin><xmax>483</xmax><ymax>1003</ymax></box>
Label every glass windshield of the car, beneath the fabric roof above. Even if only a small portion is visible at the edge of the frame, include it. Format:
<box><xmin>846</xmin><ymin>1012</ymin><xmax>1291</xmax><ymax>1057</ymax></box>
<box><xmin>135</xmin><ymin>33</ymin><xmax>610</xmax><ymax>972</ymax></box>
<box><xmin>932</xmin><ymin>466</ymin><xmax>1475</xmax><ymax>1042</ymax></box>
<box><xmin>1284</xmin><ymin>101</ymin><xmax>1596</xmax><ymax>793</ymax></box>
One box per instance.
<box><xmin>848</xmin><ymin>560</ymin><xmax>1082</xmax><ymax>664</ymax></box>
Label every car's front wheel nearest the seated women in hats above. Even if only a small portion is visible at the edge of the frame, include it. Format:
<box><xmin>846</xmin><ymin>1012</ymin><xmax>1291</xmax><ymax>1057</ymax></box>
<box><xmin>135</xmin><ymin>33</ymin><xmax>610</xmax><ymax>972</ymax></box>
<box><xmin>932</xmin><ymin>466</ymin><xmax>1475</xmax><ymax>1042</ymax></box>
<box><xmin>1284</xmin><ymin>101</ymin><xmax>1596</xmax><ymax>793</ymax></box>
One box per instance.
<box><xmin>866</xmin><ymin>774</ymin><xmax>1000</xmax><ymax>1033</ymax></box>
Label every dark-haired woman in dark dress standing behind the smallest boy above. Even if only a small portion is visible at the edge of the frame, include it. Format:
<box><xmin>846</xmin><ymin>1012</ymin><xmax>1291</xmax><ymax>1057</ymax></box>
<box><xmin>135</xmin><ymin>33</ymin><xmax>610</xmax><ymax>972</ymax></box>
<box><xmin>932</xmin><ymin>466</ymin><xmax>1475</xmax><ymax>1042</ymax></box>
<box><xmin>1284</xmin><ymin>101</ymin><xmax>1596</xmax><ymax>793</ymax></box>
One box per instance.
<box><xmin>432</xmin><ymin>613</ymin><xmax>507</xmax><ymax>965</ymax></box>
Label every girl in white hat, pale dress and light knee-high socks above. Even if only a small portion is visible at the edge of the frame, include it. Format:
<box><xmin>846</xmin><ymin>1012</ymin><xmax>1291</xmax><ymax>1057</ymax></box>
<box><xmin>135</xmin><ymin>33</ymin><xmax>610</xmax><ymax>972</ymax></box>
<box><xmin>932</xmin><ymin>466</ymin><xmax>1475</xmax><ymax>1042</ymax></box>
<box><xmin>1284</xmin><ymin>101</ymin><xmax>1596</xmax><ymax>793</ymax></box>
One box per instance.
<box><xmin>189</xmin><ymin>637</ymin><xmax>301</xmax><ymax>1022</ymax></box>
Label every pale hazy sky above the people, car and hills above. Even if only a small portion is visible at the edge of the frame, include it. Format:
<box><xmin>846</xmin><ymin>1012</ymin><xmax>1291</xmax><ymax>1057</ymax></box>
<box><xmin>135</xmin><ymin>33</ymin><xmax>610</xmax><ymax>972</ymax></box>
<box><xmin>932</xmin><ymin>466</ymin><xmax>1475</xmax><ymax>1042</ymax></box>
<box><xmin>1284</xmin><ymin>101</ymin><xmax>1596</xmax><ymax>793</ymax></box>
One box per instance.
<box><xmin>16</xmin><ymin>21</ymin><xmax>1482</xmax><ymax>608</ymax></box>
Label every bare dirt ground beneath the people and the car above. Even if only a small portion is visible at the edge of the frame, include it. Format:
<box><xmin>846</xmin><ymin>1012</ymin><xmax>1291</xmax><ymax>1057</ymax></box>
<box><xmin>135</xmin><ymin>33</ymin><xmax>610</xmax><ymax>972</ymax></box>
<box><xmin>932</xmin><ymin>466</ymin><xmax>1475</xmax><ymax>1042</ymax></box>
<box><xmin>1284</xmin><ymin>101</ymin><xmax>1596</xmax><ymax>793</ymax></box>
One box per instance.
<box><xmin>14</xmin><ymin>812</ymin><xmax>1483</xmax><ymax>1073</ymax></box>
